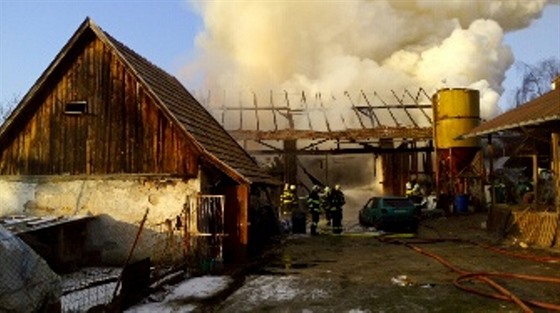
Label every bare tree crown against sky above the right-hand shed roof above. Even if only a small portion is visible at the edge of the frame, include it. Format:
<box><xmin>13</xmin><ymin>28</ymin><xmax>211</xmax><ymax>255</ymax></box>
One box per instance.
<box><xmin>515</xmin><ymin>57</ymin><xmax>560</xmax><ymax>107</ymax></box>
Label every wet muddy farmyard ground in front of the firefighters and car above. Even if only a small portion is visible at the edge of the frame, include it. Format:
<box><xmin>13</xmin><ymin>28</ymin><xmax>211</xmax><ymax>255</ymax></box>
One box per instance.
<box><xmin>207</xmin><ymin>213</ymin><xmax>560</xmax><ymax>313</ymax></box>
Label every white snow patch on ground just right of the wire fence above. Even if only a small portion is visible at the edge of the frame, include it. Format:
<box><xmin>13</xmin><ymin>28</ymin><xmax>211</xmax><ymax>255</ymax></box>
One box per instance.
<box><xmin>125</xmin><ymin>276</ymin><xmax>233</xmax><ymax>313</ymax></box>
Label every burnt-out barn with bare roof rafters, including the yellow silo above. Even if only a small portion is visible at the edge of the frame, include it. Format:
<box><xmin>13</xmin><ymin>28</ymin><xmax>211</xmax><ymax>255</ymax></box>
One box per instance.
<box><xmin>205</xmin><ymin>88</ymin><xmax>485</xmax><ymax>216</ymax></box>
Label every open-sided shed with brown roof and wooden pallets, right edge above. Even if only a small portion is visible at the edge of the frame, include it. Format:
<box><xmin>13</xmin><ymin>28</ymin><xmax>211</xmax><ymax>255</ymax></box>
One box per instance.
<box><xmin>464</xmin><ymin>77</ymin><xmax>560</xmax><ymax>247</ymax></box>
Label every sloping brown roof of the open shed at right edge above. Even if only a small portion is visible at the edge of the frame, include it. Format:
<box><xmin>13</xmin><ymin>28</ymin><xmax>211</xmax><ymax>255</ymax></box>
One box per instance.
<box><xmin>462</xmin><ymin>89</ymin><xmax>560</xmax><ymax>138</ymax></box>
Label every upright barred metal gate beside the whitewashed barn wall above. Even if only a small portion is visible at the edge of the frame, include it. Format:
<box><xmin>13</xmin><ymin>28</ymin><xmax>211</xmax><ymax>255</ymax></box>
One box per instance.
<box><xmin>185</xmin><ymin>195</ymin><xmax>226</xmax><ymax>273</ymax></box>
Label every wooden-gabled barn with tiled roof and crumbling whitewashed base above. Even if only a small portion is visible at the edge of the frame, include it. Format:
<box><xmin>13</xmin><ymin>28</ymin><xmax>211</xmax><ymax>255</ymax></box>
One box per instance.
<box><xmin>0</xmin><ymin>18</ymin><xmax>276</xmax><ymax>265</ymax></box>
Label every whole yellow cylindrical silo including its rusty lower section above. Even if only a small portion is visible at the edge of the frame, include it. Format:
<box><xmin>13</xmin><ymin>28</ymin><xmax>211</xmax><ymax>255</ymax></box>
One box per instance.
<box><xmin>432</xmin><ymin>88</ymin><xmax>480</xmax><ymax>212</ymax></box>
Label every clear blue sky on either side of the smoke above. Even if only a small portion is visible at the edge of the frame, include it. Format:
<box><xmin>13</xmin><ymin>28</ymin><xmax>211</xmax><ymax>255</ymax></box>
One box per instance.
<box><xmin>0</xmin><ymin>0</ymin><xmax>560</xmax><ymax>107</ymax></box>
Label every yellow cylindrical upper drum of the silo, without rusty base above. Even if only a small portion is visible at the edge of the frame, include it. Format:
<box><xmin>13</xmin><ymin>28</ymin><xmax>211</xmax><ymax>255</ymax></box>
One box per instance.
<box><xmin>432</xmin><ymin>88</ymin><xmax>480</xmax><ymax>149</ymax></box>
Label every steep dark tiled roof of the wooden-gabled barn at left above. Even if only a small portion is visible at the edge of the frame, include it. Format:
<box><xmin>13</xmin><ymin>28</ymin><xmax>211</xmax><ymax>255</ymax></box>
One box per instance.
<box><xmin>0</xmin><ymin>17</ymin><xmax>276</xmax><ymax>183</ymax></box>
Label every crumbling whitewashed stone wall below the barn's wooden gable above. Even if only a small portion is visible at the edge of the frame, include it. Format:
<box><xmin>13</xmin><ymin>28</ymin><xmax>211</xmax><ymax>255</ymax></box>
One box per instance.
<box><xmin>0</xmin><ymin>178</ymin><xmax>200</xmax><ymax>264</ymax></box>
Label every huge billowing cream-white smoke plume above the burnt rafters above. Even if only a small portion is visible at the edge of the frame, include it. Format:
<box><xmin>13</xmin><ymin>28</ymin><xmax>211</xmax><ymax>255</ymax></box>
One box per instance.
<box><xmin>186</xmin><ymin>0</ymin><xmax>547</xmax><ymax>118</ymax></box>
